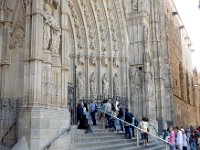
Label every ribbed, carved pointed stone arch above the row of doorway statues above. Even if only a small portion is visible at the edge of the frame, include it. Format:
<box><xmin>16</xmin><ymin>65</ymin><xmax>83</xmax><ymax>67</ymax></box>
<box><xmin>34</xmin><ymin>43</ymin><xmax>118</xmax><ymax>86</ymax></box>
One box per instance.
<box><xmin>68</xmin><ymin>0</ymin><xmax>127</xmax><ymax>99</ymax></box>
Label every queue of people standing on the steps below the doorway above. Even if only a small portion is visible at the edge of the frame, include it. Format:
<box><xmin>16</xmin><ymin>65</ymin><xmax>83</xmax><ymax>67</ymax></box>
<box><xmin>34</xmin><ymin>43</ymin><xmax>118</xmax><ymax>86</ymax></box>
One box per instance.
<box><xmin>77</xmin><ymin>99</ymin><xmax>149</xmax><ymax>146</ymax></box>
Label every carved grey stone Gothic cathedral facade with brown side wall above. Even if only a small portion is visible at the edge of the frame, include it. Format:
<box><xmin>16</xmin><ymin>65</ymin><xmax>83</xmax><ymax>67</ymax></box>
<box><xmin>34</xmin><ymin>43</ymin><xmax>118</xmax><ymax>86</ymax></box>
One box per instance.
<box><xmin>0</xmin><ymin>0</ymin><xmax>200</xmax><ymax>150</ymax></box>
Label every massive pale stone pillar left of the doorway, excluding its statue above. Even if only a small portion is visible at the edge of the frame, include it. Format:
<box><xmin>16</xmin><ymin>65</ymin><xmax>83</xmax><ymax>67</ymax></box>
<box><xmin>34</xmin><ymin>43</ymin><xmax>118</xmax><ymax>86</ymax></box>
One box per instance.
<box><xmin>18</xmin><ymin>0</ymin><xmax>70</xmax><ymax>150</ymax></box>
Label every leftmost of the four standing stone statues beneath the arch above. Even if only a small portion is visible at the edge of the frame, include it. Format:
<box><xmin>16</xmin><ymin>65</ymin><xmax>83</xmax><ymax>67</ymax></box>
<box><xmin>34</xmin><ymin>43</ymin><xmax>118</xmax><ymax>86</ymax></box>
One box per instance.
<box><xmin>77</xmin><ymin>71</ymin><xmax>85</xmax><ymax>98</ymax></box>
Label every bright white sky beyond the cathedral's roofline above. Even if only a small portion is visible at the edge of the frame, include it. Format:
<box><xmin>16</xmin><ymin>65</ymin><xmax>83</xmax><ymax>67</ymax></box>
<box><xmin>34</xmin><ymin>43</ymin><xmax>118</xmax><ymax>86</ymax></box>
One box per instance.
<box><xmin>173</xmin><ymin>0</ymin><xmax>200</xmax><ymax>72</ymax></box>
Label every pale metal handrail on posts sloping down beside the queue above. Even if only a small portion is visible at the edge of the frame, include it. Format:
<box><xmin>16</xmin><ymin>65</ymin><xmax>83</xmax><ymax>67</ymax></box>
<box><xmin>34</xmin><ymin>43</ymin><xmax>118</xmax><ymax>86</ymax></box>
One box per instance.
<box><xmin>98</xmin><ymin>109</ymin><xmax>171</xmax><ymax>149</ymax></box>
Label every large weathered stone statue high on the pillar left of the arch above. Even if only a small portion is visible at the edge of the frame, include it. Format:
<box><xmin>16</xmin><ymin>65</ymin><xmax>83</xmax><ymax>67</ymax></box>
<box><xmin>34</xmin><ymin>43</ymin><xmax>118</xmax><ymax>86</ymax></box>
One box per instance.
<box><xmin>43</xmin><ymin>0</ymin><xmax>61</xmax><ymax>54</ymax></box>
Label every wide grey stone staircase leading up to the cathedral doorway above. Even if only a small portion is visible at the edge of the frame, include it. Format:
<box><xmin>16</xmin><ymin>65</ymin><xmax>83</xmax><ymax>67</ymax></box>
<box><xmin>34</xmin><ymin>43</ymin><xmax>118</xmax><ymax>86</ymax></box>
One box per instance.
<box><xmin>71</xmin><ymin>125</ymin><xmax>165</xmax><ymax>150</ymax></box>
